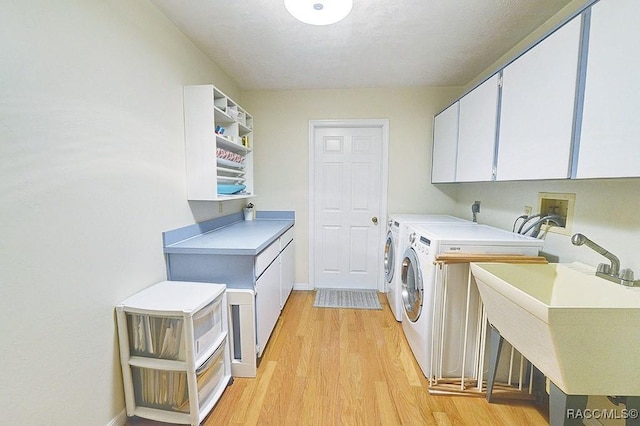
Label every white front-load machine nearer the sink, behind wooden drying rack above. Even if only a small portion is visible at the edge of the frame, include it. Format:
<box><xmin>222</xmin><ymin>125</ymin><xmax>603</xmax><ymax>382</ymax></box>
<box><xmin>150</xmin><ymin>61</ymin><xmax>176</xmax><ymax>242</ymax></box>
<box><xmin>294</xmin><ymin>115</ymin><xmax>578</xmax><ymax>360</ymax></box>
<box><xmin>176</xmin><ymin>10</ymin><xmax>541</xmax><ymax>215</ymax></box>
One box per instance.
<box><xmin>400</xmin><ymin>224</ymin><xmax>544</xmax><ymax>381</ymax></box>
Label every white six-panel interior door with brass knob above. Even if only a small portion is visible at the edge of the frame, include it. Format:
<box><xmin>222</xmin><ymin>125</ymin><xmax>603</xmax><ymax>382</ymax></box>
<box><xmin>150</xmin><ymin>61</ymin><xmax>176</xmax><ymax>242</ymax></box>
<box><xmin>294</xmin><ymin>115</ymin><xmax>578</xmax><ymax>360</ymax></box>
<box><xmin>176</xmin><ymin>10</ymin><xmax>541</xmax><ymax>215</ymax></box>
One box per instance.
<box><xmin>310</xmin><ymin>120</ymin><xmax>388</xmax><ymax>289</ymax></box>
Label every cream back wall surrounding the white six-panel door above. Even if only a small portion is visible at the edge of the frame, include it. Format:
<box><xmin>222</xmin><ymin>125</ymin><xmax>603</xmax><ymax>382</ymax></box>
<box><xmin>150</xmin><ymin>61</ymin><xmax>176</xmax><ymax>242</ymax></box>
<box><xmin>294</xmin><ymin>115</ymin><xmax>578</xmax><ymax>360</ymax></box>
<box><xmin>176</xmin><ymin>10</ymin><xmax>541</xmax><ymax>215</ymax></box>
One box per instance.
<box><xmin>241</xmin><ymin>87</ymin><xmax>460</xmax><ymax>284</ymax></box>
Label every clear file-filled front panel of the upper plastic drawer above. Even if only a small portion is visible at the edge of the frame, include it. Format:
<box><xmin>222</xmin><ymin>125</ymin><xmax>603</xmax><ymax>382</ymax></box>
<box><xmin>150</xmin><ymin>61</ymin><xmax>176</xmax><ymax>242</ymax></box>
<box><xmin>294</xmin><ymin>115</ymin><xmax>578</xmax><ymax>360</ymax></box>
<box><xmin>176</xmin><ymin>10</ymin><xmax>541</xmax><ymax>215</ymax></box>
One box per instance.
<box><xmin>127</xmin><ymin>313</ymin><xmax>185</xmax><ymax>361</ymax></box>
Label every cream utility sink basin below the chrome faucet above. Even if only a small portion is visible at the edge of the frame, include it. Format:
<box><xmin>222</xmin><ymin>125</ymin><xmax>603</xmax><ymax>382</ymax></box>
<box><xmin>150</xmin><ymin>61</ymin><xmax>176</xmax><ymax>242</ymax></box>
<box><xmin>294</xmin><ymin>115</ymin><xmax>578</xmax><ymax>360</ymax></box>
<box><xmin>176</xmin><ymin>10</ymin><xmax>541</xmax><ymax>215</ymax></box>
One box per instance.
<box><xmin>471</xmin><ymin>263</ymin><xmax>640</xmax><ymax>396</ymax></box>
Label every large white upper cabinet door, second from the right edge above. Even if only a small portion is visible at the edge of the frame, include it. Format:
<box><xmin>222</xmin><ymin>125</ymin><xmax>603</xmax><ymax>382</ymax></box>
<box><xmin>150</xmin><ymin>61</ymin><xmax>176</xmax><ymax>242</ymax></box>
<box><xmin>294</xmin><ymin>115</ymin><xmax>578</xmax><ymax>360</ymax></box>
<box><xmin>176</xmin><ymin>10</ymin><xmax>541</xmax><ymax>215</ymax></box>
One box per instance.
<box><xmin>496</xmin><ymin>16</ymin><xmax>581</xmax><ymax>180</ymax></box>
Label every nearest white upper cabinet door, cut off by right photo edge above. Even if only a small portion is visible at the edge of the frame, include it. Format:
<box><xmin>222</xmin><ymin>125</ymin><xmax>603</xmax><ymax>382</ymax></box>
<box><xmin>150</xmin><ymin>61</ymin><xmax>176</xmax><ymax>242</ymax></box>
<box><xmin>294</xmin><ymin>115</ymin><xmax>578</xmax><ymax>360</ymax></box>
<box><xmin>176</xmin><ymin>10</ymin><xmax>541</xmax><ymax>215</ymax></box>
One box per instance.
<box><xmin>576</xmin><ymin>0</ymin><xmax>640</xmax><ymax>178</ymax></box>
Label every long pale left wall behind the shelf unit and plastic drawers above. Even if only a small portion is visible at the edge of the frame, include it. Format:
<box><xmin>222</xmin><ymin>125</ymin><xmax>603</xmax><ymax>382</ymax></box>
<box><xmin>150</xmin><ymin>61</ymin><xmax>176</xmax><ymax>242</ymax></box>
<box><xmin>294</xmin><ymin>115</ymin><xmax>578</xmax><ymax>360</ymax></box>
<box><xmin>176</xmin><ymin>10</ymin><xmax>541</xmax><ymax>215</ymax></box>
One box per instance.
<box><xmin>0</xmin><ymin>0</ymin><xmax>239</xmax><ymax>425</ymax></box>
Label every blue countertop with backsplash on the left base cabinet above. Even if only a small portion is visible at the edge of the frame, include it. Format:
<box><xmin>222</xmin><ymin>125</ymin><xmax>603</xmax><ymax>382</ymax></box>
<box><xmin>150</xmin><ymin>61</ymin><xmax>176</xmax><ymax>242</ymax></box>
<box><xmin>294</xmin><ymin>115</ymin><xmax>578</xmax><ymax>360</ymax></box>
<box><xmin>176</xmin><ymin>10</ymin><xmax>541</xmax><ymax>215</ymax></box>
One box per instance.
<box><xmin>163</xmin><ymin>212</ymin><xmax>295</xmax><ymax>256</ymax></box>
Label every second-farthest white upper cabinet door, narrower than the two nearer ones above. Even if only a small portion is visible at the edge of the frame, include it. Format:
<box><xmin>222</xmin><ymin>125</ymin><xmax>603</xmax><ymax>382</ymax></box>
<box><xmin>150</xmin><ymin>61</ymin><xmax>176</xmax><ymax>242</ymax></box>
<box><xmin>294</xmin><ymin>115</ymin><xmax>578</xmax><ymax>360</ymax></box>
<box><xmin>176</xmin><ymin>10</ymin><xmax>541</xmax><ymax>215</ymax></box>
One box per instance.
<box><xmin>456</xmin><ymin>74</ymin><xmax>500</xmax><ymax>182</ymax></box>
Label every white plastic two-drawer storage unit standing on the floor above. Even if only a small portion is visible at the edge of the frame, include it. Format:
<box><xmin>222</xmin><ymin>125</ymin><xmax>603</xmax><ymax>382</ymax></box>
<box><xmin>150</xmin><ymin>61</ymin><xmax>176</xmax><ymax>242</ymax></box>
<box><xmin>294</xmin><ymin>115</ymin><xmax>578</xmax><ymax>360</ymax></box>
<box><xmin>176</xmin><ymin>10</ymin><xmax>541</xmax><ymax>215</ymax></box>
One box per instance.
<box><xmin>116</xmin><ymin>281</ymin><xmax>231</xmax><ymax>425</ymax></box>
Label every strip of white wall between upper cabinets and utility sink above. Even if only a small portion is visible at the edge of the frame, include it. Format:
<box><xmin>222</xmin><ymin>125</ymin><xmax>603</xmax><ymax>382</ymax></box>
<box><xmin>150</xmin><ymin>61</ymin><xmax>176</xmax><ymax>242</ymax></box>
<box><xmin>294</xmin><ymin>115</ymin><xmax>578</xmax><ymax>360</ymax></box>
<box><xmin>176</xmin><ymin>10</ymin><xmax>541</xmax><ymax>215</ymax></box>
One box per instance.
<box><xmin>455</xmin><ymin>179</ymin><xmax>640</xmax><ymax>272</ymax></box>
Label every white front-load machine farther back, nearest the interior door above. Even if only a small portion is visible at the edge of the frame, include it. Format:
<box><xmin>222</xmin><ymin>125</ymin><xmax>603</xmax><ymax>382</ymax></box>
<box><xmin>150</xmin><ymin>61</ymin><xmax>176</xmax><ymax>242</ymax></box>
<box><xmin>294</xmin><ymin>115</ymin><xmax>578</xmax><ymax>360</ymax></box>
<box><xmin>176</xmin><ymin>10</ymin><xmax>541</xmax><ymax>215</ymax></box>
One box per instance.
<box><xmin>384</xmin><ymin>213</ymin><xmax>472</xmax><ymax>321</ymax></box>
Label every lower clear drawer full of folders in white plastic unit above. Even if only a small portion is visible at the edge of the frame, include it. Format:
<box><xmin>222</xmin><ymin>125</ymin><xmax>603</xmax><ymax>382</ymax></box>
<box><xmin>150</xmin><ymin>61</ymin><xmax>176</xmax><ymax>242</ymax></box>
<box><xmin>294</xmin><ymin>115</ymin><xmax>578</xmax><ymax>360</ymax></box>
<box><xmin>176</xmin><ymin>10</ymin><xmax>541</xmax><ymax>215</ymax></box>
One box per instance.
<box><xmin>131</xmin><ymin>342</ymin><xmax>226</xmax><ymax>413</ymax></box>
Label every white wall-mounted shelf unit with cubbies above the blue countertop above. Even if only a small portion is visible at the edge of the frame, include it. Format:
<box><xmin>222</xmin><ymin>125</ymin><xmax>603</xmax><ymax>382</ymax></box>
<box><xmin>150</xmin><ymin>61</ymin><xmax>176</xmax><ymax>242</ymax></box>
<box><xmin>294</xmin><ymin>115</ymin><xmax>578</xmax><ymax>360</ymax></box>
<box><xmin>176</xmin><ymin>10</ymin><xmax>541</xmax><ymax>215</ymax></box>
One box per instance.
<box><xmin>184</xmin><ymin>85</ymin><xmax>254</xmax><ymax>201</ymax></box>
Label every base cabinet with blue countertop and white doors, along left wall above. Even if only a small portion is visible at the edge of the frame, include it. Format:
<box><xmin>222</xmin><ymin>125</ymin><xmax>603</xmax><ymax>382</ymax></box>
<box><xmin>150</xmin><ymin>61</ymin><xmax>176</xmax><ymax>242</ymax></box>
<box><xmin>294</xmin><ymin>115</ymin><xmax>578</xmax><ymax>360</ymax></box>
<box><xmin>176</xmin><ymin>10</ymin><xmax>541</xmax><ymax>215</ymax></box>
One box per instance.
<box><xmin>163</xmin><ymin>215</ymin><xmax>295</xmax><ymax>377</ymax></box>
